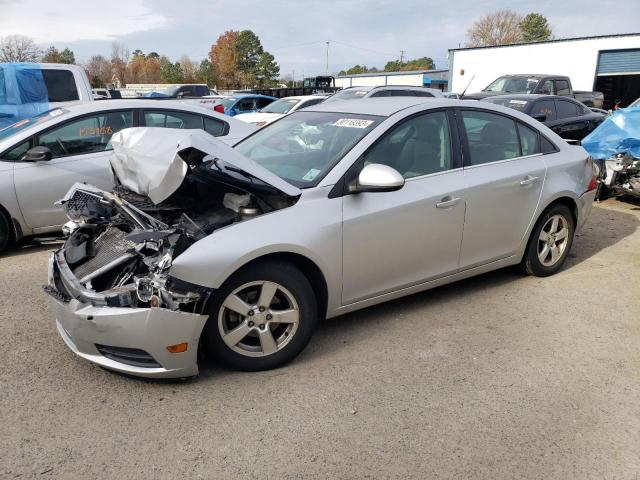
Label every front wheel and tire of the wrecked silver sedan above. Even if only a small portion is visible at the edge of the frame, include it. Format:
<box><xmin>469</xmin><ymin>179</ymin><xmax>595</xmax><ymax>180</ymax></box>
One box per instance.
<box><xmin>203</xmin><ymin>262</ymin><xmax>318</xmax><ymax>372</ymax></box>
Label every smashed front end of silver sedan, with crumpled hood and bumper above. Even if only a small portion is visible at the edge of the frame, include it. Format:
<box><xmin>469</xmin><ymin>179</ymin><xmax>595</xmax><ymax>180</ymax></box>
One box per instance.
<box><xmin>44</xmin><ymin>129</ymin><xmax>297</xmax><ymax>377</ymax></box>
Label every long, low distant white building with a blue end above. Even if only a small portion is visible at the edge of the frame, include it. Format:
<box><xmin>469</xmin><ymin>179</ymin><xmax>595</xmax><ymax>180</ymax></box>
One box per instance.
<box><xmin>336</xmin><ymin>70</ymin><xmax>448</xmax><ymax>90</ymax></box>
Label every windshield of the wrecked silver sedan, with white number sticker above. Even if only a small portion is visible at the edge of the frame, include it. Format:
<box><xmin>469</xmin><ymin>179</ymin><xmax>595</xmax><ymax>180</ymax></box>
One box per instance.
<box><xmin>234</xmin><ymin>111</ymin><xmax>384</xmax><ymax>188</ymax></box>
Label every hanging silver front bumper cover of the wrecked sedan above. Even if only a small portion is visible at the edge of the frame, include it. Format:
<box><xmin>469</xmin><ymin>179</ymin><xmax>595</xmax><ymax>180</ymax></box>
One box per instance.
<box><xmin>44</xmin><ymin>251</ymin><xmax>208</xmax><ymax>378</ymax></box>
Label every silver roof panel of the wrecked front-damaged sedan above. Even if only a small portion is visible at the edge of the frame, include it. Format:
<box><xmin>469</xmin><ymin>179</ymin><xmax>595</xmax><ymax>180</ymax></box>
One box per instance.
<box><xmin>303</xmin><ymin>97</ymin><xmax>484</xmax><ymax>117</ymax></box>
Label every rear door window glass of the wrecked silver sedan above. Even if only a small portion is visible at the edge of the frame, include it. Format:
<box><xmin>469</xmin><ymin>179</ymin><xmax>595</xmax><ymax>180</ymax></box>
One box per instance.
<box><xmin>462</xmin><ymin>110</ymin><xmax>520</xmax><ymax>165</ymax></box>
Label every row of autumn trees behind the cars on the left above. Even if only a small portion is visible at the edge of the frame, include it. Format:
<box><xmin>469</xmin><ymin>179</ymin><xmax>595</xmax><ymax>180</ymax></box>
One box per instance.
<box><xmin>0</xmin><ymin>30</ymin><xmax>280</xmax><ymax>88</ymax></box>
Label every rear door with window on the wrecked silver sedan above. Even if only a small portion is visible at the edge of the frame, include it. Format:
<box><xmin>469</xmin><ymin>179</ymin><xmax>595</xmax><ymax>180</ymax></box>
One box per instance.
<box><xmin>458</xmin><ymin>109</ymin><xmax>546</xmax><ymax>269</ymax></box>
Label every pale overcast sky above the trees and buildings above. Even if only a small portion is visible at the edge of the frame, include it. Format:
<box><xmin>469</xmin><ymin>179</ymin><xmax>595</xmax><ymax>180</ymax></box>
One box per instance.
<box><xmin>0</xmin><ymin>0</ymin><xmax>640</xmax><ymax>78</ymax></box>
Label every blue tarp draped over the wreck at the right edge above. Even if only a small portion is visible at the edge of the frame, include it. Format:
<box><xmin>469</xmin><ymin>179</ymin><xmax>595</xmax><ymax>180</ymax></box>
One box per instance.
<box><xmin>582</xmin><ymin>107</ymin><xmax>640</xmax><ymax>160</ymax></box>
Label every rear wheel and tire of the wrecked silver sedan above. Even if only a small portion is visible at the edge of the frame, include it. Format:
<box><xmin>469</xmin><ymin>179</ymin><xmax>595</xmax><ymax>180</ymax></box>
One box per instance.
<box><xmin>522</xmin><ymin>204</ymin><xmax>575</xmax><ymax>277</ymax></box>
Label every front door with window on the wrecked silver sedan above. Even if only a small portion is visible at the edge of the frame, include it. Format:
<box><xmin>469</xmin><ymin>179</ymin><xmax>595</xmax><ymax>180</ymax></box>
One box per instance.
<box><xmin>342</xmin><ymin>111</ymin><xmax>465</xmax><ymax>305</ymax></box>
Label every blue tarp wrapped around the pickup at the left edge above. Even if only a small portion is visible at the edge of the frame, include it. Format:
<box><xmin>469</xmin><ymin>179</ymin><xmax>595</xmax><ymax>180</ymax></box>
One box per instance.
<box><xmin>0</xmin><ymin>63</ymin><xmax>50</xmax><ymax>129</ymax></box>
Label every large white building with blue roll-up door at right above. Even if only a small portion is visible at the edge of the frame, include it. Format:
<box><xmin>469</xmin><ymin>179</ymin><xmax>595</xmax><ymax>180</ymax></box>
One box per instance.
<box><xmin>449</xmin><ymin>33</ymin><xmax>640</xmax><ymax>108</ymax></box>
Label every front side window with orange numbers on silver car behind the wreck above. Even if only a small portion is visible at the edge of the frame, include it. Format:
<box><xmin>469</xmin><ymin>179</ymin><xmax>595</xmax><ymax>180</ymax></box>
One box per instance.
<box><xmin>38</xmin><ymin>111</ymin><xmax>133</xmax><ymax>158</ymax></box>
